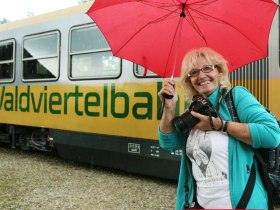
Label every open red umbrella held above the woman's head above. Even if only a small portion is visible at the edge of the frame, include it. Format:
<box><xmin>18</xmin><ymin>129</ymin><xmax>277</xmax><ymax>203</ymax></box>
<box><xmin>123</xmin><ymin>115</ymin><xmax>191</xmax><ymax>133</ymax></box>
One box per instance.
<box><xmin>87</xmin><ymin>0</ymin><xmax>278</xmax><ymax>77</ymax></box>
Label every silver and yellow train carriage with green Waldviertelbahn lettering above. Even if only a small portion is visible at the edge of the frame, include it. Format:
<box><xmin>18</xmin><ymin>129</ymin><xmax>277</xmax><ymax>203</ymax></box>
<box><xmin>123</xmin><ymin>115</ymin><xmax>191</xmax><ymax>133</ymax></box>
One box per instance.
<box><xmin>0</xmin><ymin>3</ymin><xmax>280</xmax><ymax>179</ymax></box>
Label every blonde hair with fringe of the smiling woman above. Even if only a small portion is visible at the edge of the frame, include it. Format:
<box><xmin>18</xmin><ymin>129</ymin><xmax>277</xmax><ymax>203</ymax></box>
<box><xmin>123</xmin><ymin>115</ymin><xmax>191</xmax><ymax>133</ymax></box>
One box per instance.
<box><xmin>180</xmin><ymin>47</ymin><xmax>231</xmax><ymax>101</ymax></box>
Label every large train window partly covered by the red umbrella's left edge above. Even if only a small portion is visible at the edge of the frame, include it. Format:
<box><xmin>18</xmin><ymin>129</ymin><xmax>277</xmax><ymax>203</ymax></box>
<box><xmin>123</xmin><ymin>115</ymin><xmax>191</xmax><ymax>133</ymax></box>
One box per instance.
<box><xmin>69</xmin><ymin>25</ymin><xmax>121</xmax><ymax>79</ymax></box>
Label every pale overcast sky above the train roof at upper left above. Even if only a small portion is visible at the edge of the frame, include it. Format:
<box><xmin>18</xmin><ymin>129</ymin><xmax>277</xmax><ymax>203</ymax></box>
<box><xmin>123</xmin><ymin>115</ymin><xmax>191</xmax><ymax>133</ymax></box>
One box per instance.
<box><xmin>0</xmin><ymin>0</ymin><xmax>78</xmax><ymax>21</ymax></box>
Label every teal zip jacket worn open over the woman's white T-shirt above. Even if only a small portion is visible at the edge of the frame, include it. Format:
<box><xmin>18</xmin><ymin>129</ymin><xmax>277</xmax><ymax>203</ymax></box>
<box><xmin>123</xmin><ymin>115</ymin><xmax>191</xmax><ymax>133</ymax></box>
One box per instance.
<box><xmin>158</xmin><ymin>86</ymin><xmax>280</xmax><ymax>210</ymax></box>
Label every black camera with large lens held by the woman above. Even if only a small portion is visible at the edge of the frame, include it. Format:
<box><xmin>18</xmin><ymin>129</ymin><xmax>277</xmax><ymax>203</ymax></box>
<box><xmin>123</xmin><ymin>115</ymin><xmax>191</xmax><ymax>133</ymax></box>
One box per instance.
<box><xmin>173</xmin><ymin>95</ymin><xmax>218</xmax><ymax>132</ymax></box>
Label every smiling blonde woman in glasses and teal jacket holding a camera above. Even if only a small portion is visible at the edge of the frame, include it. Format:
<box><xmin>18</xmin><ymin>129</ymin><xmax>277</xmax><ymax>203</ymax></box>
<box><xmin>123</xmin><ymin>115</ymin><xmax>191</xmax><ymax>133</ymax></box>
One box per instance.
<box><xmin>158</xmin><ymin>48</ymin><xmax>280</xmax><ymax>209</ymax></box>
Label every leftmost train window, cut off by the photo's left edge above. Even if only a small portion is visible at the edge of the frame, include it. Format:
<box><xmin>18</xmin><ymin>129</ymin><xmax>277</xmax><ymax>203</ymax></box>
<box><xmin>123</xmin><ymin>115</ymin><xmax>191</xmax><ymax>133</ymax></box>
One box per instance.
<box><xmin>0</xmin><ymin>40</ymin><xmax>15</xmax><ymax>83</ymax></box>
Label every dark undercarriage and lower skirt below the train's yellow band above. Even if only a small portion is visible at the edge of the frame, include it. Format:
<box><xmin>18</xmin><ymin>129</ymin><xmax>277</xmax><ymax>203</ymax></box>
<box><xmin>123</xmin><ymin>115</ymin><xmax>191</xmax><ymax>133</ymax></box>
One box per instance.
<box><xmin>0</xmin><ymin>124</ymin><xmax>180</xmax><ymax>180</ymax></box>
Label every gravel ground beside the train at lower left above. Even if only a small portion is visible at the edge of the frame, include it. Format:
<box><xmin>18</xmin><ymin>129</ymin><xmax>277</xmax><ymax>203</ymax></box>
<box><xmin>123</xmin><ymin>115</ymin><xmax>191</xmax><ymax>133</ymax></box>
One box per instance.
<box><xmin>0</xmin><ymin>146</ymin><xmax>176</xmax><ymax>210</ymax></box>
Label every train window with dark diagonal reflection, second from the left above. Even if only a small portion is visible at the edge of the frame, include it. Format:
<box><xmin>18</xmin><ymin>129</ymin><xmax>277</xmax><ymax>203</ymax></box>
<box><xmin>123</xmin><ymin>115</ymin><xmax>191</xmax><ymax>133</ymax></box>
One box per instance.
<box><xmin>22</xmin><ymin>31</ymin><xmax>60</xmax><ymax>81</ymax></box>
